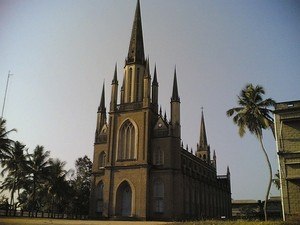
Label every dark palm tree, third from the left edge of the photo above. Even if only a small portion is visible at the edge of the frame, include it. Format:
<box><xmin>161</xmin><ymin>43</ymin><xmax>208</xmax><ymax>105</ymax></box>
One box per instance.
<box><xmin>27</xmin><ymin>145</ymin><xmax>50</xmax><ymax>210</ymax></box>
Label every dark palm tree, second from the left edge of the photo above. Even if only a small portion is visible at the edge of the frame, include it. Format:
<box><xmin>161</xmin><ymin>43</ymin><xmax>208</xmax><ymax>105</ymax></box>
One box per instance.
<box><xmin>1</xmin><ymin>141</ymin><xmax>28</xmax><ymax>208</ymax></box>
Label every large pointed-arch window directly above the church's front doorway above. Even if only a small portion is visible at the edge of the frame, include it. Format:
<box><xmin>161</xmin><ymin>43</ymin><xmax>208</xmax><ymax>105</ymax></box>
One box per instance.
<box><xmin>118</xmin><ymin>120</ymin><xmax>137</xmax><ymax>160</ymax></box>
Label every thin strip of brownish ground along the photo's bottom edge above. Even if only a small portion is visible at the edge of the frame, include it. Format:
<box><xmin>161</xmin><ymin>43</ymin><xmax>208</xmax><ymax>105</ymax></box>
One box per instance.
<box><xmin>0</xmin><ymin>218</ymin><xmax>300</xmax><ymax>225</ymax></box>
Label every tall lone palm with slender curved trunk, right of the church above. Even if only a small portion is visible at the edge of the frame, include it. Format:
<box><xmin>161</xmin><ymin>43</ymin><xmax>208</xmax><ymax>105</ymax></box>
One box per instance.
<box><xmin>227</xmin><ymin>84</ymin><xmax>275</xmax><ymax>220</ymax></box>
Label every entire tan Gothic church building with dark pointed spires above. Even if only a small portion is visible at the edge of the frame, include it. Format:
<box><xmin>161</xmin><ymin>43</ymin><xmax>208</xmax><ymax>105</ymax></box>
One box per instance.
<box><xmin>90</xmin><ymin>0</ymin><xmax>231</xmax><ymax>220</ymax></box>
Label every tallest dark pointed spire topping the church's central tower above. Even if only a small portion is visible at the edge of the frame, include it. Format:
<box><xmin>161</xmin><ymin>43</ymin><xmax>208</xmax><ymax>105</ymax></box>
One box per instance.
<box><xmin>126</xmin><ymin>0</ymin><xmax>145</xmax><ymax>64</ymax></box>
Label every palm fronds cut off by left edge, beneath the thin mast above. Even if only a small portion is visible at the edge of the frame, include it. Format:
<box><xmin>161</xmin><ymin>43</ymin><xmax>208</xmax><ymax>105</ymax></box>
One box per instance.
<box><xmin>0</xmin><ymin>117</ymin><xmax>16</xmax><ymax>164</ymax></box>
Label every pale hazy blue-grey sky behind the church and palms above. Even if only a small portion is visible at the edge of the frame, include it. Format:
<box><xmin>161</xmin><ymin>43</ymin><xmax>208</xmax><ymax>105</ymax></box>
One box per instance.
<box><xmin>0</xmin><ymin>0</ymin><xmax>300</xmax><ymax>199</ymax></box>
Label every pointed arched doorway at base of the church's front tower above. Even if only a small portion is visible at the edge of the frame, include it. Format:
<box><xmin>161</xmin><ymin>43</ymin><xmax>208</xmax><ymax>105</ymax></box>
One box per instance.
<box><xmin>116</xmin><ymin>181</ymin><xmax>132</xmax><ymax>217</ymax></box>
